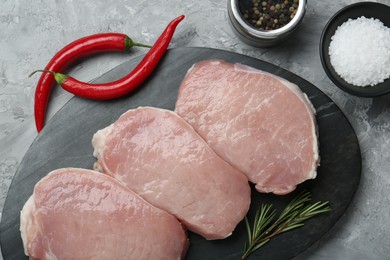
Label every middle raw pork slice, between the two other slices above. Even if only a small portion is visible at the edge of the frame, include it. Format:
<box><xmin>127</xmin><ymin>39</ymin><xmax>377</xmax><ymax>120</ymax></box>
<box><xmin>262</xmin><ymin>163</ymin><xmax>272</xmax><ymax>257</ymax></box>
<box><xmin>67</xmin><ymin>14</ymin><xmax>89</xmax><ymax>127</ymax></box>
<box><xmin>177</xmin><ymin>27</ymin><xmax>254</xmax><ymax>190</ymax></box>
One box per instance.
<box><xmin>92</xmin><ymin>107</ymin><xmax>250</xmax><ymax>239</ymax></box>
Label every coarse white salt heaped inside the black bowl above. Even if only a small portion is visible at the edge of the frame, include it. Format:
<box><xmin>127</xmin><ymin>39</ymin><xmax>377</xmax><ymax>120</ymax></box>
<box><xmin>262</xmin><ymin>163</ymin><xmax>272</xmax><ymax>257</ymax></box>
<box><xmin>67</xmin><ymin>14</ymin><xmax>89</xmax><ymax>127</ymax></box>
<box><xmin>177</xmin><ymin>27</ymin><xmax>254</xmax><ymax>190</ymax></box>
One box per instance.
<box><xmin>329</xmin><ymin>16</ymin><xmax>390</xmax><ymax>87</ymax></box>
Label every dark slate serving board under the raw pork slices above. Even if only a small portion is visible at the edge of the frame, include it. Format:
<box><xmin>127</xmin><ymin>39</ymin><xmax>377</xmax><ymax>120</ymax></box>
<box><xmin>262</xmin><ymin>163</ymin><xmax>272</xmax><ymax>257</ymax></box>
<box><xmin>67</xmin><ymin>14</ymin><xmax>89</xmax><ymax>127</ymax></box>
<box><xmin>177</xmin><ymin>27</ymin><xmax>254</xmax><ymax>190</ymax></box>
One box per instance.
<box><xmin>0</xmin><ymin>48</ymin><xmax>361</xmax><ymax>260</ymax></box>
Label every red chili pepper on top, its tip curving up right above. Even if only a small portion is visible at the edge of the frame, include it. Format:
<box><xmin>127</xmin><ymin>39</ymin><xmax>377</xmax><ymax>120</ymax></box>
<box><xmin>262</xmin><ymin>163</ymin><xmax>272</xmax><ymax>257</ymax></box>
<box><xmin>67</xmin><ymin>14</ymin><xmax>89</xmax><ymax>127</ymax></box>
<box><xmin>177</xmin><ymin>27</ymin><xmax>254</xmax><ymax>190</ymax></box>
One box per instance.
<box><xmin>30</xmin><ymin>15</ymin><xmax>184</xmax><ymax>106</ymax></box>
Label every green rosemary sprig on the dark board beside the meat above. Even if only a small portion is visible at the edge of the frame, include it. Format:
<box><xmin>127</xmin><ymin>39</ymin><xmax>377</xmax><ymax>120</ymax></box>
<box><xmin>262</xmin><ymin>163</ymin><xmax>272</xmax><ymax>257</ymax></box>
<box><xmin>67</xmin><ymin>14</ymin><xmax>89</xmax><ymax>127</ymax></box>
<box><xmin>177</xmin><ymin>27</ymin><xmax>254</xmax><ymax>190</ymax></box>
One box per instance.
<box><xmin>241</xmin><ymin>192</ymin><xmax>331</xmax><ymax>259</ymax></box>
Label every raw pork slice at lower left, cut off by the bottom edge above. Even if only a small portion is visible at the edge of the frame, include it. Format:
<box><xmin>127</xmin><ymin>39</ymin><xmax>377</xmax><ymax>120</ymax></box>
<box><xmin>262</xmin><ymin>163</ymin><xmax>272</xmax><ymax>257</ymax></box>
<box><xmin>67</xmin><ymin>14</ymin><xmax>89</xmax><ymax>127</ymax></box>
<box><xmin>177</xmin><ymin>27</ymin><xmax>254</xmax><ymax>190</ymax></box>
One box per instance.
<box><xmin>20</xmin><ymin>168</ymin><xmax>188</xmax><ymax>260</ymax></box>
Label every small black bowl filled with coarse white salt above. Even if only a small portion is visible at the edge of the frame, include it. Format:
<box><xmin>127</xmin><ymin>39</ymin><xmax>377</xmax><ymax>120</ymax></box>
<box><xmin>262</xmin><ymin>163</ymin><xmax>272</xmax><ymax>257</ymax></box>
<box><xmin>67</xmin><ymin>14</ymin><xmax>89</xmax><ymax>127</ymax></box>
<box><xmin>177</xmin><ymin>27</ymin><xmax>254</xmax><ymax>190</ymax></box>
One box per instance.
<box><xmin>320</xmin><ymin>2</ymin><xmax>390</xmax><ymax>97</ymax></box>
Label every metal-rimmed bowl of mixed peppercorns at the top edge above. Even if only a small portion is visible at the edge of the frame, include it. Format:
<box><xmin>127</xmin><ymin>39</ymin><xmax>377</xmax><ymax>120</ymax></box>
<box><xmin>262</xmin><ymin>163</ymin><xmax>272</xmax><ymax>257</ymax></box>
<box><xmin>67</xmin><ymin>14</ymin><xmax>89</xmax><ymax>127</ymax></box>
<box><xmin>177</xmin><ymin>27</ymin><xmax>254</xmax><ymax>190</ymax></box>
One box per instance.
<box><xmin>228</xmin><ymin>0</ymin><xmax>307</xmax><ymax>47</ymax></box>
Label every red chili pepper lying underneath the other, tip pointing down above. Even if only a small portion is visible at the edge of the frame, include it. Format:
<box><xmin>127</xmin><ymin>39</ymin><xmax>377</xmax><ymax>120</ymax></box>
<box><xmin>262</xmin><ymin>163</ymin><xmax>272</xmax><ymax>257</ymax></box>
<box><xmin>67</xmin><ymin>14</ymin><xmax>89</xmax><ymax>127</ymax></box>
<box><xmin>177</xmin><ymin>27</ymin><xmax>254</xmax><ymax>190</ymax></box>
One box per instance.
<box><xmin>34</xmin><ymin>33</ymin><xmax>151</xmax><ymax>132</ymax></box>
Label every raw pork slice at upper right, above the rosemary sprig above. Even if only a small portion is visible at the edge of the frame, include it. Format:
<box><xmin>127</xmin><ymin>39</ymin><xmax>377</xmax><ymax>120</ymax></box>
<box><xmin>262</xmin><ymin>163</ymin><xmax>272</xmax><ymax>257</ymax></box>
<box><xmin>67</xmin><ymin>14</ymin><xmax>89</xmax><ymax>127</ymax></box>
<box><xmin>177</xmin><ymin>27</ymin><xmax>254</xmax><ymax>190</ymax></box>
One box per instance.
<box><xmin>175</xmin><ymin>60</ymin><xmax>319</xmax><ymax>195</ymax></box>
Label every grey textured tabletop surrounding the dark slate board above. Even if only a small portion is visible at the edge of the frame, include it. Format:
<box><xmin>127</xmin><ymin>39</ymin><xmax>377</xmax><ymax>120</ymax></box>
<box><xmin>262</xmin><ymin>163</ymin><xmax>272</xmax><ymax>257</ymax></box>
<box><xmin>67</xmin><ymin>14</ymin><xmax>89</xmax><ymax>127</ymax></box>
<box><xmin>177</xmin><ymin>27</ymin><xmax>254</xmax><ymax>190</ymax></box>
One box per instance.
<box><xmin>0</xmin><ymin>0</ymin><xmax>390</xmax><ymax>259</ymax></box>
